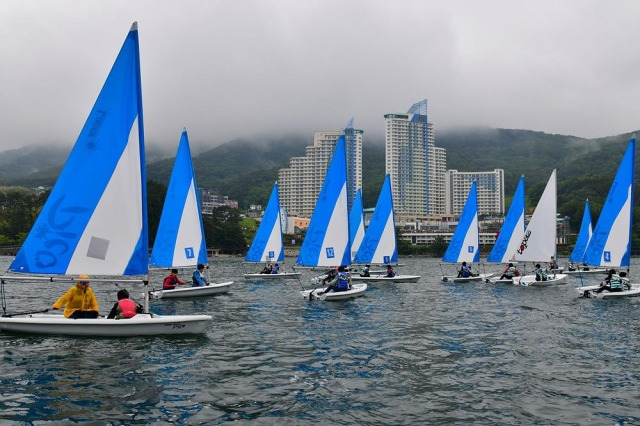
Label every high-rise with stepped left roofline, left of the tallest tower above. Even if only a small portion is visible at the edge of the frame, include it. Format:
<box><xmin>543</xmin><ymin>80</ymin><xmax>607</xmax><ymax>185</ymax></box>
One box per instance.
<box><xmin>278</xmin><ymin>120</ymin><xmax>364</xmax><ymax>217</ymax></box>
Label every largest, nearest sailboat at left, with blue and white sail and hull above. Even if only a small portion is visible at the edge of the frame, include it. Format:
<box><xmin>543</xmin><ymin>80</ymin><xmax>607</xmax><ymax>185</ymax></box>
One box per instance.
<box><xmin>0</xmin><ymin>23</ymin><xmax>212</xmax><ymax>336</ymax></box>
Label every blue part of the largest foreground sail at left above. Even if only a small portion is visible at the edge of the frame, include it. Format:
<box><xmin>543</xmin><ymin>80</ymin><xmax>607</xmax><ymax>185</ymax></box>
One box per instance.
<box><xmin>9</xmin><ymin>26</ymin><xmax>149</xmax><ymax>274</ymax></box>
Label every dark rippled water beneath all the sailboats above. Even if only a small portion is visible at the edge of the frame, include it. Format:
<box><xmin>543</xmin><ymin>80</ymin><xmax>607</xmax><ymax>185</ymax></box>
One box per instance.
<box><xmin>0</xmin><ymin>258</ymin><xmax>640</xmax><ymax>425</ymax></box>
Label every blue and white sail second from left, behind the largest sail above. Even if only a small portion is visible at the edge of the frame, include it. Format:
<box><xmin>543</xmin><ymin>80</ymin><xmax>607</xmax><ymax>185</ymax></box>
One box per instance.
<box><xmin>149</xmin><ymin>130</ymin><xmax>207</xmax><ymax>268</ymax></box>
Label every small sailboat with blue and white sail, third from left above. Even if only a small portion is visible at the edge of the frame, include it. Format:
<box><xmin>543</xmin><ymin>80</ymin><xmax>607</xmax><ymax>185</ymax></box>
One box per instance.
<box><xmin>244</xmin><ymin>182</ymin><xmax>301</xmax><ymax>280</ymax></box>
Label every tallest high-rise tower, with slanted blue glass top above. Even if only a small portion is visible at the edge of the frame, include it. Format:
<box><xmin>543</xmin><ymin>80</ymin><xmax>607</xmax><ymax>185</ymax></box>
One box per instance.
<box><xmin>384</xmin><ymin>99</ymin><xmax>446</xmax><ymax>217</ymax></box>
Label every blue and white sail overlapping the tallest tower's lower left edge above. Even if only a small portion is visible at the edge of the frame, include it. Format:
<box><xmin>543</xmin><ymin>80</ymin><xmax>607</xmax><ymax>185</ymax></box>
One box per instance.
<box><xmin>354</xmin><ymin>175</ymin><xmax>398</xmax><ymax>264</ymax></box>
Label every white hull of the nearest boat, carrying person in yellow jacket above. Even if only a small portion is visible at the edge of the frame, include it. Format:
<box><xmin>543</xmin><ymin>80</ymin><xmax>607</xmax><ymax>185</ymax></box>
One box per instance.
<box><xmin>0</xmin><ymin>314</ymin><xmax>213</xmax><ymax>337</ymax></box>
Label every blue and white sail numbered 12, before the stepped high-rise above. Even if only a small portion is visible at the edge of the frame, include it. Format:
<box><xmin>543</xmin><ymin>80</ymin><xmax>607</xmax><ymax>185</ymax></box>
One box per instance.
<box><xmin>296</xmin><ymin>135</ymin><xmax>351</xmax><ymax>267</ymax></box>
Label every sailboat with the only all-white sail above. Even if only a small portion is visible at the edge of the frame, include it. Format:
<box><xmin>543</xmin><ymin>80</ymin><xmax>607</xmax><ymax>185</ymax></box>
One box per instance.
<box><xmin>513</xmin><ymin>169</ymin><xmax>567</xmax><ymax>286</ymax></box>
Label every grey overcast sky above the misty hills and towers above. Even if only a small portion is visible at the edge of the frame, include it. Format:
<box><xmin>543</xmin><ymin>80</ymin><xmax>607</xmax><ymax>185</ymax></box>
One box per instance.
<box><xmin>0</xmin><ymin>0</ymin><xmax>640</xmax><ymax>150</ymax></box>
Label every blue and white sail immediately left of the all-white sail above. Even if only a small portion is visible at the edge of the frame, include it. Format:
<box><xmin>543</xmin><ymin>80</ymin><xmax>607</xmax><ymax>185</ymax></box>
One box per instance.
<box><xmin>487</xmin><ymin>176</ymin><xmax>524</xmax><ymax>263</ymax></box>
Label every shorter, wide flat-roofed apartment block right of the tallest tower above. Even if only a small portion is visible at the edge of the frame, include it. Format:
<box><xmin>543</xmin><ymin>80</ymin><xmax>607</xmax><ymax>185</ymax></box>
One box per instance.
<box><xmin>446</xmin><ymin>169</ymin><xmax>504</xmax><ymax>215</ymax></box>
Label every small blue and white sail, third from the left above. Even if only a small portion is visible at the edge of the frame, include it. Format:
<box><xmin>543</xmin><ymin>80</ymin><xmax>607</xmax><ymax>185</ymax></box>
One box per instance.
<box><xmin>245</xmin><ymin>183</ymin><xmax>284</xmax><ymax>262</ymax></box>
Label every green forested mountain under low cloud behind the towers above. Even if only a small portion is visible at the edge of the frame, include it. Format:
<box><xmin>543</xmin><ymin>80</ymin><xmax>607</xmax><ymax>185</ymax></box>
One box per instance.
<box><xmin>0</xmin><ymin>128</ymin><xmax>638</xmax><ymax>236</ymax></box>
